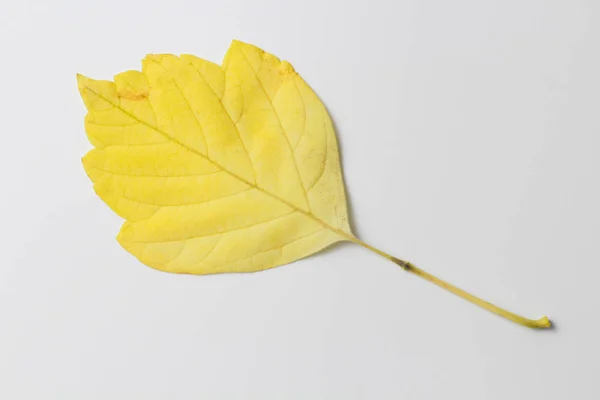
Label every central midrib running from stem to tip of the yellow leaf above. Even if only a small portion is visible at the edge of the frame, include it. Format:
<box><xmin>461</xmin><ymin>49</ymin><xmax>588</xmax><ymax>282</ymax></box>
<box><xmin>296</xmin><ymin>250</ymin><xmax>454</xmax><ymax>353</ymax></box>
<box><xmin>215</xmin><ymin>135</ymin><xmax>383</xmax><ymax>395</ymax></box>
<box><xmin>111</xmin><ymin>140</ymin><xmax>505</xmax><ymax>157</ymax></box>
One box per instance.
<box><xmin>83</xmin><ymin>84</ymin><xmax>356</xmax><ymax>246</ymax></box>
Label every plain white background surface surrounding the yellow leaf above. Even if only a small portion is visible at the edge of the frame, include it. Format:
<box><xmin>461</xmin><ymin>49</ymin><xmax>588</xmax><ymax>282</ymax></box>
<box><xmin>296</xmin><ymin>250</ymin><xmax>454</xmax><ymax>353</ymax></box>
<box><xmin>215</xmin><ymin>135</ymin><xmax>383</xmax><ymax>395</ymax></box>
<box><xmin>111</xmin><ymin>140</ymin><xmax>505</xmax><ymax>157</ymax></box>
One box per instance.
<box><xmin>0</xmin><ymin>0</ymin><xmax>600</xmax><ymax>400</ymax></box>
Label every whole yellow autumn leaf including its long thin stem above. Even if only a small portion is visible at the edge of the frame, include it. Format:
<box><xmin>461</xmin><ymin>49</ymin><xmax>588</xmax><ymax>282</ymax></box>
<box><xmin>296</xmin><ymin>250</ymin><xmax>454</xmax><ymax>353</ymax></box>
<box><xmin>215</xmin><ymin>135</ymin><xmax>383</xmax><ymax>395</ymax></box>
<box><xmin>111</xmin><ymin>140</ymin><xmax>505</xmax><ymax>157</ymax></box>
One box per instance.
<box><xmin>78</xmin><ymin>41</ymin><xmax>549</xmax><ymax>327</ymax></box>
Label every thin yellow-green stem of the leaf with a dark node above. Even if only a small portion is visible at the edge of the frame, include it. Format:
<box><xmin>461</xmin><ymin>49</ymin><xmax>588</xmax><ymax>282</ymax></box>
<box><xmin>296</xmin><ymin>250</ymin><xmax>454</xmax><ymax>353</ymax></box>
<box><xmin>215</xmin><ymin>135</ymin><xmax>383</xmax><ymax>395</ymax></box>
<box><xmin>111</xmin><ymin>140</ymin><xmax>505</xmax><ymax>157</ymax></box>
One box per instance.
<box><xmin>348</xmin><ymin>236</ymin><xmax>552</xmax><ymax>329</ymax></box>
